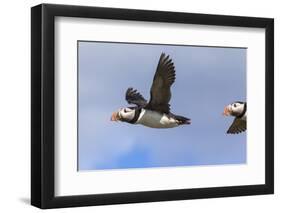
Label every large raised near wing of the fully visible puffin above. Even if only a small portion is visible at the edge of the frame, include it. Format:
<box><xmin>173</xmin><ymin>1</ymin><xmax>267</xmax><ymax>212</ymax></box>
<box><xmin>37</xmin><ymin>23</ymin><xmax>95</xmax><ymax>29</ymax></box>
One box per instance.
<box><xmin>145</xmin><ymin>53</ymin><xmax>176</xmax><ymax>113</ymax></box>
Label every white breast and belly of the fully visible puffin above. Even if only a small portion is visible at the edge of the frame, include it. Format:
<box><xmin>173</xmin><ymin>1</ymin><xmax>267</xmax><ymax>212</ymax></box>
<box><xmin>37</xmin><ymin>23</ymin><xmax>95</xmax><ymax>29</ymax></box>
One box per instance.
<box><xmin>136</xmin><ymin>109</ymin><xmax>178</xmax><ymax>128</ymax></box>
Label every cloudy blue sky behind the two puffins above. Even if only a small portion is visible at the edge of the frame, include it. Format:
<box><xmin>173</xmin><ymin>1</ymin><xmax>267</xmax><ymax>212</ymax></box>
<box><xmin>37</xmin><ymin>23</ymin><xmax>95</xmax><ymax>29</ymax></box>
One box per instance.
<box><xmin>78</xmin><ymin>41</ymin><xmax>247</xmax><ymax>170</ymax></box>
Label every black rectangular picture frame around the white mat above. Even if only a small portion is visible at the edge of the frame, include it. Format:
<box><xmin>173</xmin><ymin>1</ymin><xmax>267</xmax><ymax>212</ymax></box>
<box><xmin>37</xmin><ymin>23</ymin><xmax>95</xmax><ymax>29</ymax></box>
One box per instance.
<box><xmin>31</xmin><ymin>4</ymin><xmax>274</xmax><ymax>209</ymax></box>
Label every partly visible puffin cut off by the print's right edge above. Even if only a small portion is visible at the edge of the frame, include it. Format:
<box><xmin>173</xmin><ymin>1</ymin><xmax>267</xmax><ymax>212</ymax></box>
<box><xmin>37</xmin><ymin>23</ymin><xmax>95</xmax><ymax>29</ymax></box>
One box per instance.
<box><xmin>223</xmin><ymin>101</ymin><xmax>247</xmax><ymax>134</ymax></box>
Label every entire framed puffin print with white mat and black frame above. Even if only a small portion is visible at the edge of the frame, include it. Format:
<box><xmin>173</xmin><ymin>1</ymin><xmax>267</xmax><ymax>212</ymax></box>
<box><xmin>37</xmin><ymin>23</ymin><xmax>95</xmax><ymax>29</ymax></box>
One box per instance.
<box><xmin>31</xmin><ymin>4</ymin><xmax>274</xmax><ymax>208</ymax></box>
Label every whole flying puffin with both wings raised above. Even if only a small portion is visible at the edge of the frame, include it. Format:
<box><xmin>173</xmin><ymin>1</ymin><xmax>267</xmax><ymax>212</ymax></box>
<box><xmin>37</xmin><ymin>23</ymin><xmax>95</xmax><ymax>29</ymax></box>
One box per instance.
<box><xmin>111</xmin><ymin>53</ymin><xmax>190</xmax><ymax>128</ymax></box>
